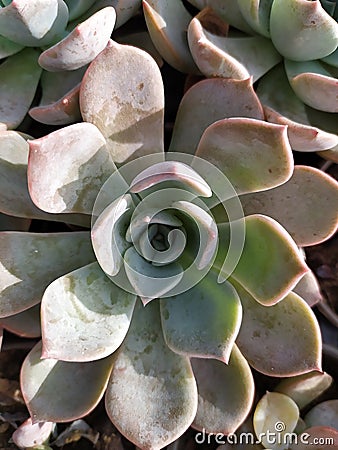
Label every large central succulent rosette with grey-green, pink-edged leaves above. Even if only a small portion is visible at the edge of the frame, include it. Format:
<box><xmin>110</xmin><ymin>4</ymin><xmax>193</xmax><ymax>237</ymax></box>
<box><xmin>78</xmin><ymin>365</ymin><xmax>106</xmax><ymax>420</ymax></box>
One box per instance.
<box><xmin>0</xmin><ymin>41</ymin><xmax>338</xmax><ymax>449</ymax></box>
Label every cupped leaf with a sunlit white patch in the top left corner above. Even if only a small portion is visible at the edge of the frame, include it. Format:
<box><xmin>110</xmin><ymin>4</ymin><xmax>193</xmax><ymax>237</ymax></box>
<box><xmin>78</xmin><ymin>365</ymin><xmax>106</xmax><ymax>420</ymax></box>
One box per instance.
<box><xmin>0</xmin><ymin>0</ymin><xmax>69</xmax><ymax>47</ymax></box>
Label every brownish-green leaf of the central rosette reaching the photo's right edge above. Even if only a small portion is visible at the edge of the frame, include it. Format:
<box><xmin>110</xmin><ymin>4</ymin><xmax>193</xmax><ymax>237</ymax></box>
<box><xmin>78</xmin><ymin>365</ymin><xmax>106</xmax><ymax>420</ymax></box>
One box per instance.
<box><xmin>240</xmin><ymin>166</ymin><xmax>338</xmax><ymax>247</ymax></box>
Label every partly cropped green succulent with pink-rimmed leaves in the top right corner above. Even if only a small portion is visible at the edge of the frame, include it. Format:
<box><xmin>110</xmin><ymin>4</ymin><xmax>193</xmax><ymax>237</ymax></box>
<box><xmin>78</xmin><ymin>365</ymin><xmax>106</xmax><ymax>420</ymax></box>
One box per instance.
<box><xmin>143</xmin><ymin>0</ymin><xmax>338</xmax><ymax>162</ymax></box>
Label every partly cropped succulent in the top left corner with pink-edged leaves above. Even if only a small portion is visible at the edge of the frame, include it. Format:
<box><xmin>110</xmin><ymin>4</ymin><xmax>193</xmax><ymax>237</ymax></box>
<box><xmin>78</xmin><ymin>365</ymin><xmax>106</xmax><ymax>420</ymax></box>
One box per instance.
<box><xmin>0</xmin><ymin>0</ymin><xmax>141</xmax><ymax>129</ymax></box>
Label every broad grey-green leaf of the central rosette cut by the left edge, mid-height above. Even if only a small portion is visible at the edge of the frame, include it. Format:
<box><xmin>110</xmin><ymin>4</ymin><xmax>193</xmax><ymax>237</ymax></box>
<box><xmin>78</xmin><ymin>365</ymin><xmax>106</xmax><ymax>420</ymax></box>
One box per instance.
<box><xmin>0</xmin><ymin>231</ymin><xmax>95</xmax><ymax>317</ymax></box>
